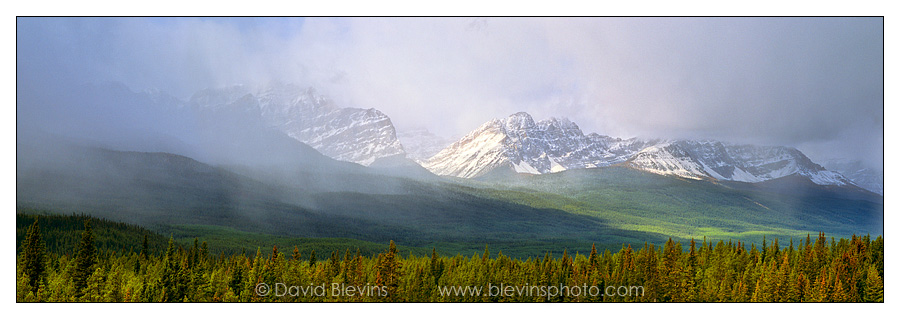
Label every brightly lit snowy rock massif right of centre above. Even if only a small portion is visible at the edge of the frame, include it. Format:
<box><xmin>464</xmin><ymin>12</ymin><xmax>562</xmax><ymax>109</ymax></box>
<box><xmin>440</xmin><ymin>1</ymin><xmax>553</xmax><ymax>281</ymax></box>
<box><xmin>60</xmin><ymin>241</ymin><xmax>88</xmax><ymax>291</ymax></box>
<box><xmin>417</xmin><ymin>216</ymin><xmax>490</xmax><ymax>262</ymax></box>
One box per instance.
<box><xmin>423</xmin><ymin>112</ymin><xmax>852</xmax><ymax>185</ymax></box>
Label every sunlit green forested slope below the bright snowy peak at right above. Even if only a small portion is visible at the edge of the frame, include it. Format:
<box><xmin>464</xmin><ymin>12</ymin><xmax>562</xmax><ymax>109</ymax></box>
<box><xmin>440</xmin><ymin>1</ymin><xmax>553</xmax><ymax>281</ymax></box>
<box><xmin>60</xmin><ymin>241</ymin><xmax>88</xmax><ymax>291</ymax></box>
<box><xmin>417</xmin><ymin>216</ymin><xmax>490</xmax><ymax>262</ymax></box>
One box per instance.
<box><xmin>472</xmin><ymin>167</ymin><xmax>883</xmax><ymax>241</ymax></box>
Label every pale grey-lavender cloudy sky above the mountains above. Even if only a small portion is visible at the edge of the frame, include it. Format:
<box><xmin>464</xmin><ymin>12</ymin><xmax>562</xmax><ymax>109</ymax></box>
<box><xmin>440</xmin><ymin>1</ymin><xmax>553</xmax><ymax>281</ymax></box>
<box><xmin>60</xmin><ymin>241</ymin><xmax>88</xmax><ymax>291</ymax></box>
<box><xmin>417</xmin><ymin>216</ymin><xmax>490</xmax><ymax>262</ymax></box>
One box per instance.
<box><xmin>16</xmin><ymin>18</ymin><xmax>884</xmax><ymax>167</ymax></box>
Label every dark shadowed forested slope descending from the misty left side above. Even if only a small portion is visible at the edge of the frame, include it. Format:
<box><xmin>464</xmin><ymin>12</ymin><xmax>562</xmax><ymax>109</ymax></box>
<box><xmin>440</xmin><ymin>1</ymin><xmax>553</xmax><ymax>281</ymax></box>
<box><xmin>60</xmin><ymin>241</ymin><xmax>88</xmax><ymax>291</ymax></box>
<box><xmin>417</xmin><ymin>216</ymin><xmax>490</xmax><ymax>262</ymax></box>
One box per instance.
<box><xmin>16</xmin><ymin>145</ymin><xmax>662</xmax><ymax>253</ymax></box>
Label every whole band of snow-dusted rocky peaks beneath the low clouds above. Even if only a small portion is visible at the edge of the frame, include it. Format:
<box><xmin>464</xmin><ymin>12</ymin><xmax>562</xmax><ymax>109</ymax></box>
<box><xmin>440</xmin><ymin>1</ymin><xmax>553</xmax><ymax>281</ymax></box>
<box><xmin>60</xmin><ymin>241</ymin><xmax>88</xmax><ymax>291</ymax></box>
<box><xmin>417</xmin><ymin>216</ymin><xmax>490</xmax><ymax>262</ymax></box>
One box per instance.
<box><xmin>38</xmin><ymin>82</ymin><xmax>883</xmax><ymax>194</ymax></box>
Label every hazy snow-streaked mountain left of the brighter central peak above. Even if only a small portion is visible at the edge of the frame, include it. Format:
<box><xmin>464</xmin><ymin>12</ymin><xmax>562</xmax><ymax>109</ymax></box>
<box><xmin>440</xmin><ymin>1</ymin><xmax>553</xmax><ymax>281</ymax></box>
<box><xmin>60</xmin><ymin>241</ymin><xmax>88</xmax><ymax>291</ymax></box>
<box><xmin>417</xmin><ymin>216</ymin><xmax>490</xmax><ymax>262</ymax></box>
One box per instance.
<box><xmin>190</xmin><ymin>84</ymin><xmax>405</xmax><ymax>165</ymax></box>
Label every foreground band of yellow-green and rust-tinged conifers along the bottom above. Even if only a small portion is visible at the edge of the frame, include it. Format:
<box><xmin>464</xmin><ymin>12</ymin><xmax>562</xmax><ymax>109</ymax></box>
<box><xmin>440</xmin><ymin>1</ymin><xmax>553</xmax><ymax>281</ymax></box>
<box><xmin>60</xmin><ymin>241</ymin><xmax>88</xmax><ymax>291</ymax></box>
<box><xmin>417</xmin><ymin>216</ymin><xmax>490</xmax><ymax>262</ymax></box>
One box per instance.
<box><xmin>16</xmin><ymin>221</ymin><xmax>884</xmax><ymax>302</ymax></box>
